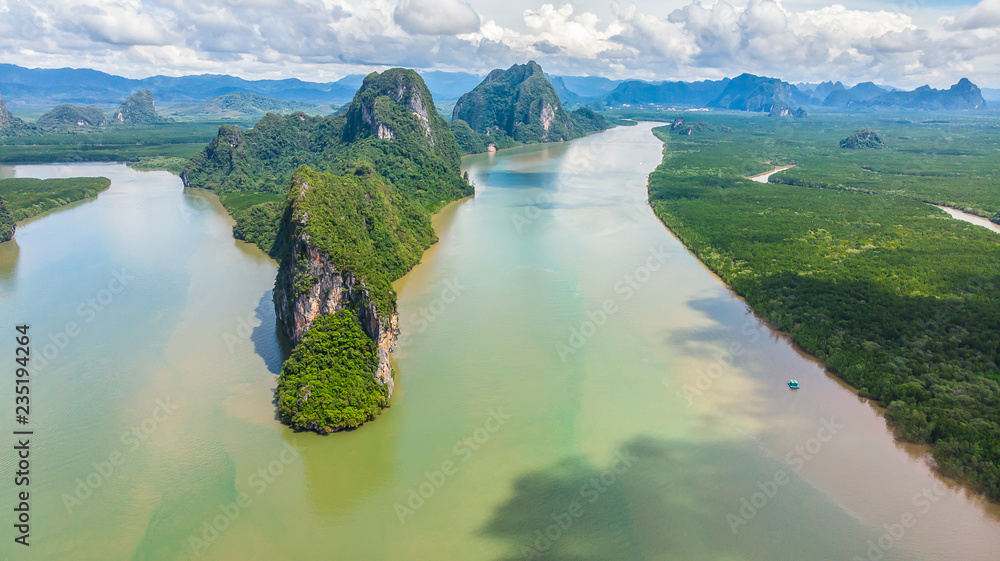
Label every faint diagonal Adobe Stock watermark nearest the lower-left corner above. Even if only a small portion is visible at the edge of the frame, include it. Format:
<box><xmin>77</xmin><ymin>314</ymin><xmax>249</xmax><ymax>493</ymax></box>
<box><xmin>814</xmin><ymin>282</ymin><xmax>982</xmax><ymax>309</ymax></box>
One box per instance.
<box><xmin>62</xmin><ymin>397</ymin><xmax>180</xmax><ymax>514</ymax></box>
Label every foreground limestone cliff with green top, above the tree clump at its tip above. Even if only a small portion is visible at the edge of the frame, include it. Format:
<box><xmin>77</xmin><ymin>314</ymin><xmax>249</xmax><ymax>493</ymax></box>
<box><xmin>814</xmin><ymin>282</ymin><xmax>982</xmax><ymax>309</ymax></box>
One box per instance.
<box><xmin>274</xmin><ymin>165</ymin><xmax>436</xmax><ymax>395</ymax></box>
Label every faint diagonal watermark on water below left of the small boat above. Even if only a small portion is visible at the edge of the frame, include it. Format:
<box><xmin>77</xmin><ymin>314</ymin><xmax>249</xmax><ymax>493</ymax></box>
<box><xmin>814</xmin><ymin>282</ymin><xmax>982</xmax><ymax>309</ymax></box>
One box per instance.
<box><xmin>726</xmin><ymin>417</ymin><xmax>845</xmax><ymax>535</ymax></box>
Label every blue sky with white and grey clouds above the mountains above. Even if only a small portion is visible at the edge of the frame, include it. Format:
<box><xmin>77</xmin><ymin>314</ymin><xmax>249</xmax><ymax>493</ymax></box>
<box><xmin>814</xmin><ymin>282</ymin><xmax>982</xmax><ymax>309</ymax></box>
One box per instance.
<box><xmin>0</xmin><ymin>0</ymin><xmax>1000</xmax><ymax>87</ymax></box>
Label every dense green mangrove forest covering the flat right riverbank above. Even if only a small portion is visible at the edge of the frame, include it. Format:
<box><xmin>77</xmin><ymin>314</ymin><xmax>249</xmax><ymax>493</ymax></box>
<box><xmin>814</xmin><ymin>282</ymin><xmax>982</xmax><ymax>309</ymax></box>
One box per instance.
<box><xmin>649</xmin><ymin>116</ymin><xmax>1000</xmax><ymax>499</ymax></box>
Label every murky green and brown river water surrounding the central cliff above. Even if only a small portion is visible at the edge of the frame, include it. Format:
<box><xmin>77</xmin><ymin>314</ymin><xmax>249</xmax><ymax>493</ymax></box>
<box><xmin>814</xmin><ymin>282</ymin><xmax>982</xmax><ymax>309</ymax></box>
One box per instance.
<box><xmin>0</xmin><ymin>124</ymin><xmax>1000</xmax><ymax>561</ymax></box>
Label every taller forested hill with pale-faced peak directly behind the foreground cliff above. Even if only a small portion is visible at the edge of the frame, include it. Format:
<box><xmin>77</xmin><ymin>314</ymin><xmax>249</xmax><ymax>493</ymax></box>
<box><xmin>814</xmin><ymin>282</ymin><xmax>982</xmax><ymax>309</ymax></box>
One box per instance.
<box><xmin>182</xmin><ymin>68</ymin><xmax>472</xmax><ymax>256</ymax></box>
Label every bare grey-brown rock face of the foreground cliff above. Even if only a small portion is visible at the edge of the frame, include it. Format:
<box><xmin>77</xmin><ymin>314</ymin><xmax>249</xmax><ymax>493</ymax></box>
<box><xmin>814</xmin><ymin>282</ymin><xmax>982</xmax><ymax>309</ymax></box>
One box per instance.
<box><xmin>274</xmin><ymin>177</ymin><xmax>399</xmax><ymax>396</ymax></box>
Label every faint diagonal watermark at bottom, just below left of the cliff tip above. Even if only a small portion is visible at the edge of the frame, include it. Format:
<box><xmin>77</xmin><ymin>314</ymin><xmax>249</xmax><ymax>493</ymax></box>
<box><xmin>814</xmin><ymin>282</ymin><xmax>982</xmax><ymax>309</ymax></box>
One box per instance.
<box><xmin>188</xmin><ymin>442</ymin><xmax>302</xmax><ymax>557</ymax></box>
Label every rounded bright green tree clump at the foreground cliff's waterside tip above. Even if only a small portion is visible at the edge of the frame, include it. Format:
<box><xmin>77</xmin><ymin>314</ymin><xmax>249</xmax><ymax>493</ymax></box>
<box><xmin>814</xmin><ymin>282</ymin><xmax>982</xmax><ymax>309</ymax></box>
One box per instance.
<box><xmin>274</xmin><ymin>308</ymin><xmax>389</xmax><ymax>433</ymax></box>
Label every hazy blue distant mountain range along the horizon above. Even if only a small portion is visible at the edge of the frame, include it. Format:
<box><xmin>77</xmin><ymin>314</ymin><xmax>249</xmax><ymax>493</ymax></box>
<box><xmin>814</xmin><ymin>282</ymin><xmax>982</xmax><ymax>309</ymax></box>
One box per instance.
<box><xmin>0</xmin><ymin>64</ymin><xmax>988</xmax><ymax>118</ymax></box>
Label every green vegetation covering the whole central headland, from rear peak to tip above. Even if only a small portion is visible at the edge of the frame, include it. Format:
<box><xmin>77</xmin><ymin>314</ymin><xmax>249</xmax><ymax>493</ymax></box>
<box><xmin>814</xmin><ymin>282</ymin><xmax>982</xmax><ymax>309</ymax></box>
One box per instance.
<box><xmin>181</xmin><ymin>68</ymin><xmax>472</xmax><ymax>432</ymax></box>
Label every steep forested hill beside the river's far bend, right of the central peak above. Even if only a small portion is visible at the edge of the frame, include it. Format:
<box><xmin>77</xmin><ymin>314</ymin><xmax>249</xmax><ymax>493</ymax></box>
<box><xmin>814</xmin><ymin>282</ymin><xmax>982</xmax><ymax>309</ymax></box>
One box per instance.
<box><xmin>452</xmin><ymin>61</ymin><xmax>608</xmax><ymax>152</ymax></box>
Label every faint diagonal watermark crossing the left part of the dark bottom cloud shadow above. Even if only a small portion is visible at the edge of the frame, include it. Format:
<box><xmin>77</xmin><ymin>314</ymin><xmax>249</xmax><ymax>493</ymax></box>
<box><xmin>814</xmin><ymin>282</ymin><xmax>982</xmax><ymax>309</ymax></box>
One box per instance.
<box><xmin>520</xmin><ymin>451</ymin><xmax>637</xmax><ymax>561</ymax></box>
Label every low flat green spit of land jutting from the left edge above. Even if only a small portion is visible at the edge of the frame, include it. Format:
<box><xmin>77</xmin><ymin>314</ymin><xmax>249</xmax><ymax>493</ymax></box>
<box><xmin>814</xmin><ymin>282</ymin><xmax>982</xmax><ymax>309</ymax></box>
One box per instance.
<box><xmin>0</xmin><ymin>177</ymin><xmax>111</xmax><ymax>222</ymax></box>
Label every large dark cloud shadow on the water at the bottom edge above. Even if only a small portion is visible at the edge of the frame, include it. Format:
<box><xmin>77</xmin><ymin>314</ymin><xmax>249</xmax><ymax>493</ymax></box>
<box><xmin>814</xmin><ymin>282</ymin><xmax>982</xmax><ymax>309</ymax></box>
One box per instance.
<box><xmin>480</xmin><ymin>436</ymin><xmax>905</xmax><ymax>561</ymax></box>
